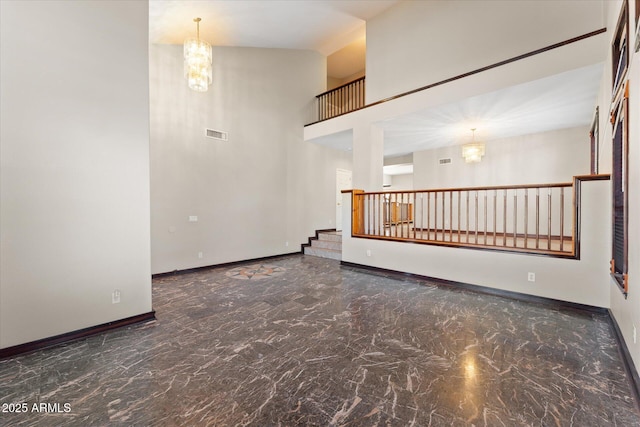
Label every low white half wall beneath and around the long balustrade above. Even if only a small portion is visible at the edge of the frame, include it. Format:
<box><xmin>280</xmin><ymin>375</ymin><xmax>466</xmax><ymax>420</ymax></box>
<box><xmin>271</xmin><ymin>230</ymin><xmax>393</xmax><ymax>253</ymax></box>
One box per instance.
<box><xmin>342</xmin><ymin>181</ymin><xmax>611</xmax><ymax>307</ymax></box>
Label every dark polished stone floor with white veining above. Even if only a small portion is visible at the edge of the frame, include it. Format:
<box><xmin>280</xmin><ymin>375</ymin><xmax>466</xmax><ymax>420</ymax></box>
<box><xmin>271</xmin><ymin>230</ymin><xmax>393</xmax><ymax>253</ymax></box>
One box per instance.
<box><xmin>0</xmin><ymin>255</ymin><xmax>640</xmax><ymax>427</ymax></box>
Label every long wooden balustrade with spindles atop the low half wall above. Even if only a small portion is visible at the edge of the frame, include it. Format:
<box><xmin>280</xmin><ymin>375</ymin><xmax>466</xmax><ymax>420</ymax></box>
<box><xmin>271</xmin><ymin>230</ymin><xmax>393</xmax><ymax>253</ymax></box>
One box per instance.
<box><xmin>351</xmin><ymin>178</ymin><xmax>592</xmax><ymax>258</ymax></box>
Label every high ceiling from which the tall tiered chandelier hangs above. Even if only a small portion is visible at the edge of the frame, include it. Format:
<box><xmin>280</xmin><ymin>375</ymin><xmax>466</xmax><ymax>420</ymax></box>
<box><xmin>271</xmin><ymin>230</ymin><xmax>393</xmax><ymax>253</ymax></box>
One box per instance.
<box><xmin>149</xmin><ymin>0</ymin><xmax>398</xmax><ymax>55</ymax></box>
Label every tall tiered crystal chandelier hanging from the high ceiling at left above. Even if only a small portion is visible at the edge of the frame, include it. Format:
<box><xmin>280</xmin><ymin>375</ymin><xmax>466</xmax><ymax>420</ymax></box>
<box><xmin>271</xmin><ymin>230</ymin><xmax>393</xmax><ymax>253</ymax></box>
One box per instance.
<box><xmin>184</xmin><ymin>18</ymin><xmax>213</xmax><ymax>92</ymax></box>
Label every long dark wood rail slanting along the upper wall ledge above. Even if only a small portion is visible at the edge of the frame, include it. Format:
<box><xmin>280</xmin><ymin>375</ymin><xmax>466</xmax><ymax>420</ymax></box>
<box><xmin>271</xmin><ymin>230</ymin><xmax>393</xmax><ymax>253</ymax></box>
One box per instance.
<box><xmin>305</xmin><ymin>27</ymin><xmax>607</xmax><ymax>127</ymax></box>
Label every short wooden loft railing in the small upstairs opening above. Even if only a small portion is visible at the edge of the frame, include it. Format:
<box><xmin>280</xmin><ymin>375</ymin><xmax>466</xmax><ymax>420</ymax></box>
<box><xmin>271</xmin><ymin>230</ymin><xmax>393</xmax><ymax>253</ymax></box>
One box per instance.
<box><xmin>316</xmin><ymin>77</ymin><xmax>365</xmax><ymax>121</ymax></box>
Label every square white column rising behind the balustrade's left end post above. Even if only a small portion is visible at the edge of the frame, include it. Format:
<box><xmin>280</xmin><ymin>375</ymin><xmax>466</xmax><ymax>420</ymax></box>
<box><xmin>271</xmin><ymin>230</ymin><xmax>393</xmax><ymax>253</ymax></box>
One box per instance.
<box><xmin>353</xmin><ymin>123</ymin><xmax>384</xmax><ymax>191</ymax></box>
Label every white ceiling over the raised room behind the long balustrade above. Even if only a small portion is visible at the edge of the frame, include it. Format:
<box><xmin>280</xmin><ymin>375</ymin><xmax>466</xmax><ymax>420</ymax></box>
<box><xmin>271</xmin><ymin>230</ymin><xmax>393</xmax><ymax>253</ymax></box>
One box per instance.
<box><xmin>313</xmin><ymin>63</ymin><xmax>603</xmax><ymax>157</ymax></box>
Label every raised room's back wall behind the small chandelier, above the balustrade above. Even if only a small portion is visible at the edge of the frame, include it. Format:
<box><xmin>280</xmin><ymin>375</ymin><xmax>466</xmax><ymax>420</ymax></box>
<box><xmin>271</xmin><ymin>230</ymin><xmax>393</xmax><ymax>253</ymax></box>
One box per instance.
<box><xmin>413</xmin><ymin>126</ymin><xmax>590</xmax><ymax>189</ymax></box>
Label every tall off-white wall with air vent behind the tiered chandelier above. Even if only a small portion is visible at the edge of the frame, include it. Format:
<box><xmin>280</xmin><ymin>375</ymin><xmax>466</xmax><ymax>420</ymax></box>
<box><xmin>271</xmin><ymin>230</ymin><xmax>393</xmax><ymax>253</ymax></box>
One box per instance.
<box><xmin>150</xmin><ymin>45</ymin><xmax>351</xmax><ymax>273</ymax></box>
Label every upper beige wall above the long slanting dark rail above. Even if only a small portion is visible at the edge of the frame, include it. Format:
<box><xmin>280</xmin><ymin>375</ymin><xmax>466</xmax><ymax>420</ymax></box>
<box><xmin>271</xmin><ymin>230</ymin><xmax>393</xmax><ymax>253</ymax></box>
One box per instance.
<box><xmin>366</xmin><ymin>0</ymin><xmax>605</xmax><ymax>103</ymax></box>
